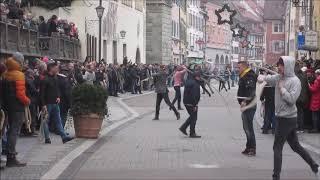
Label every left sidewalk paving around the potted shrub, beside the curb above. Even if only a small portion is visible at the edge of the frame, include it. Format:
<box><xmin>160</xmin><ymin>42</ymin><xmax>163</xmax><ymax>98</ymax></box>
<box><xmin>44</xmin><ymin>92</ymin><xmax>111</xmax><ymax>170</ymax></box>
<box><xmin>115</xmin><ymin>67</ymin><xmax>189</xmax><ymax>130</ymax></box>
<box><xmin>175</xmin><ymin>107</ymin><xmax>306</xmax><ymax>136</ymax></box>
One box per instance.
<box><xmin>0</xmin><ymin>97</ymin><xmax>130</xmax><ymax>180</ymax></box>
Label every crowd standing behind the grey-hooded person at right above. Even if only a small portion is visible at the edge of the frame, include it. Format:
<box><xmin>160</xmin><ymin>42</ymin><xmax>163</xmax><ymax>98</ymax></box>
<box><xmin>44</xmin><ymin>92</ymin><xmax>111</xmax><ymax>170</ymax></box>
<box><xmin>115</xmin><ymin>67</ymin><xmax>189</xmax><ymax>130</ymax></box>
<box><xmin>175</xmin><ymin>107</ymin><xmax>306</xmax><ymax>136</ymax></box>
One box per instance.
<box><xmin>260</xmin><ymin>58</ymin><xmax>320</xmax><ymax>134</ymax></box>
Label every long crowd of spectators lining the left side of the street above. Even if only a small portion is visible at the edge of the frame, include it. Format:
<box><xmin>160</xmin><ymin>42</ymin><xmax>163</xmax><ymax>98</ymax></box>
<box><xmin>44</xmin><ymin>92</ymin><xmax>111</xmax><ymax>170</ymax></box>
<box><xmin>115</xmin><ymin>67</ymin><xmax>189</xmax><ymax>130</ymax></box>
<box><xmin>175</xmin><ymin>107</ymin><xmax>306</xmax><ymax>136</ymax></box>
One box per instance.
<box><xmin>0</xmin><ymin>52</ymin><xmax>215</xmax><ymax>167</ymax></box>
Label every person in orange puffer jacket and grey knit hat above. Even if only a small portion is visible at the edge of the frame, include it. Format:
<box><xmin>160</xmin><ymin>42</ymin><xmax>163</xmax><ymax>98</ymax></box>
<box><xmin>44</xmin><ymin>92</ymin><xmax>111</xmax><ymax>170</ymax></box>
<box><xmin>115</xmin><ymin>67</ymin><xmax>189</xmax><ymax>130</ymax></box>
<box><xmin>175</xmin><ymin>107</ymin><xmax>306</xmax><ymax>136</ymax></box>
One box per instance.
<box><xmin>1</xmin><ymin>52</ymin><xmax>30</xmax><ymax>167</ymax></box>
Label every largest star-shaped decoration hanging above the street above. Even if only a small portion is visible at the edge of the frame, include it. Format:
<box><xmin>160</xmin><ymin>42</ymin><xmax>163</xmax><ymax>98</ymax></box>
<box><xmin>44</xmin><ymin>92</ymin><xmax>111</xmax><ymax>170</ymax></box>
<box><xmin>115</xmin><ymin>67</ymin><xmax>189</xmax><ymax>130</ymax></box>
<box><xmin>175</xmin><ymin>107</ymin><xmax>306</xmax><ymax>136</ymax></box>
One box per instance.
<box><xmin>215</xmin><ymin>4</ymin><xmax>237</xmax><ymax>25</ymax></box>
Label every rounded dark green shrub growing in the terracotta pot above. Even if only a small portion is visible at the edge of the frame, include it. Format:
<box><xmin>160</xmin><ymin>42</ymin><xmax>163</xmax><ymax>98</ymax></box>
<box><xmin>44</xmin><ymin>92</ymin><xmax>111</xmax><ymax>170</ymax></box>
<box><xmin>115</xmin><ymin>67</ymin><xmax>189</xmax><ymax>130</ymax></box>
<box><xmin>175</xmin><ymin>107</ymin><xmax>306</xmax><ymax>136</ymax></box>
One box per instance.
<box><xmin>71</xmin><ymin>83</ymin><xmax>108</xmax><ymax>116</ymax></box>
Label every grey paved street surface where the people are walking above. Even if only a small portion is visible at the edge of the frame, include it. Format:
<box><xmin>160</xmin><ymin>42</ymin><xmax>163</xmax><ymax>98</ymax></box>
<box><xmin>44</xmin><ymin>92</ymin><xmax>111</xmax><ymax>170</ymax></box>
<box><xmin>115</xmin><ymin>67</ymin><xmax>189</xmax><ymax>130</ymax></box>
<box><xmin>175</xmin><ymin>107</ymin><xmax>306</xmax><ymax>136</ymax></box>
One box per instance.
<box><xmin>60</xmin><ymin>90</ymin><xmax>319</xmax><ymax>180</ymax></box>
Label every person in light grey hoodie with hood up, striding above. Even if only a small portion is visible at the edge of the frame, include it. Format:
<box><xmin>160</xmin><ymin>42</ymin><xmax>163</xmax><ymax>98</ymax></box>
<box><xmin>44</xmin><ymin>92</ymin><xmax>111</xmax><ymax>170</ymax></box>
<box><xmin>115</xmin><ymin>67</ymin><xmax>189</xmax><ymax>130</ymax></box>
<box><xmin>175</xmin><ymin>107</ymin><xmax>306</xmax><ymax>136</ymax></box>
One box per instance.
<box><xmin>258</xmin><ymin>56</ymin><xmax>319</xmax><ymax>180</ymax></box>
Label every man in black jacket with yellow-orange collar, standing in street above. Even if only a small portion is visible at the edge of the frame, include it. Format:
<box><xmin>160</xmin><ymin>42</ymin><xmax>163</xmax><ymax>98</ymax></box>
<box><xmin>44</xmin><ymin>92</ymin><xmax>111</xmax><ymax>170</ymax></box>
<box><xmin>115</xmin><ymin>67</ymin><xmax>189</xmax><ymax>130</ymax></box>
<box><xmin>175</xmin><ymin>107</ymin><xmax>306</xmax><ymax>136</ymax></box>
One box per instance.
<box><xmin>237</xmin><ymin>61</ymin><xmax>257</xmax><ymax>156</ymax></box>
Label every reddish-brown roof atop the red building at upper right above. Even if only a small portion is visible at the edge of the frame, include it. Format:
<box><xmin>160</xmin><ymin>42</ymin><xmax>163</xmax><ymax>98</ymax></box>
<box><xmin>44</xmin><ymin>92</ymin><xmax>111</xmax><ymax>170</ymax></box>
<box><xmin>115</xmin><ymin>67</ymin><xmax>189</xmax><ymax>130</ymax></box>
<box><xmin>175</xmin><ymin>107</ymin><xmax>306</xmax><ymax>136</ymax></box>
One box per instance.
<box><xmin>263</xmin><ymin>0</ymin><xmax>287</xmax><ymax>20</ymax></box>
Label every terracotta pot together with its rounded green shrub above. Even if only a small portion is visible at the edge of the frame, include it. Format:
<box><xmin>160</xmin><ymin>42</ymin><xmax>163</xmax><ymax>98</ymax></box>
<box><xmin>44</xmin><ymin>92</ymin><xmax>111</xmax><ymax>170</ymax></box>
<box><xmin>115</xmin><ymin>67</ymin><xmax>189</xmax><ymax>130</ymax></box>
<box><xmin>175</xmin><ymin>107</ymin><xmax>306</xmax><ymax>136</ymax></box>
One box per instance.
<box><xmin>70</xmin><ymin>83</ymin><xmax>108</xmax><ymax>138</ymax></box>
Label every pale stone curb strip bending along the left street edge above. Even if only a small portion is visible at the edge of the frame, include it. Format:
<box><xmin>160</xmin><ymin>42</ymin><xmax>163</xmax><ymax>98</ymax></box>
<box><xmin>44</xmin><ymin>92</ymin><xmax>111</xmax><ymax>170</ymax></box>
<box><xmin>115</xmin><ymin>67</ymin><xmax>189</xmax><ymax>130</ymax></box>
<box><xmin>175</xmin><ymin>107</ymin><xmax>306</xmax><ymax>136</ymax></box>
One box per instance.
<box><xmin>40</xmin><ymin>96</ymin><xmax>139</xmax><ymax>180</ymax></box>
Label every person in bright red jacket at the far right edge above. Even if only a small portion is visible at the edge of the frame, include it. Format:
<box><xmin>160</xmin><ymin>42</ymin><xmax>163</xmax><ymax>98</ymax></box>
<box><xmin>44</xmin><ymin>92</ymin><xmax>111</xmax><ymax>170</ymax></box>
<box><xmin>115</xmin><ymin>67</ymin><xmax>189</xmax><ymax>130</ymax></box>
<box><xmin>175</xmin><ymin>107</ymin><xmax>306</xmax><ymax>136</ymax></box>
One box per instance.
<box><xmin>309</xmin><ymin>69</ymin><xmax>320</xmax><ymax>133</ymax></box>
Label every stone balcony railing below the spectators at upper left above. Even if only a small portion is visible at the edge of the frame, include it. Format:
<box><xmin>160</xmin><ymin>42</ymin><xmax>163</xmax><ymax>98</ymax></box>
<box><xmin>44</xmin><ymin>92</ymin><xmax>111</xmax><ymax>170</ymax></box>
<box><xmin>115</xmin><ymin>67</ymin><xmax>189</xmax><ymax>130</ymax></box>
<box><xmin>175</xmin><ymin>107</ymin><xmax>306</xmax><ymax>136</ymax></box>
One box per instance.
<box><xmin>0</xmin><ymin>21</ymin><xmax>81</xmax><ymax>61</ymax></box>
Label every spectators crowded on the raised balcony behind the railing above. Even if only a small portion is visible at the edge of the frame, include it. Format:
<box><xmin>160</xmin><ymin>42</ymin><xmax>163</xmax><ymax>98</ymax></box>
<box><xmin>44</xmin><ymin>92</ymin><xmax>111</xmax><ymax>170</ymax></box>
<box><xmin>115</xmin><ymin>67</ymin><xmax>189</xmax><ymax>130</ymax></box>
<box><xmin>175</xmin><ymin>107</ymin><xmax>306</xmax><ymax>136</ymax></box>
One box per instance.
<box><xmin>0</xmin><ymin>0</ymin><xmax>78</xmax><ymax>38</ymax></box>
